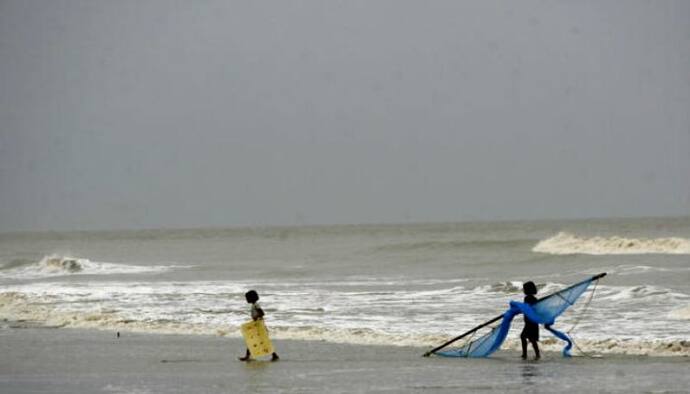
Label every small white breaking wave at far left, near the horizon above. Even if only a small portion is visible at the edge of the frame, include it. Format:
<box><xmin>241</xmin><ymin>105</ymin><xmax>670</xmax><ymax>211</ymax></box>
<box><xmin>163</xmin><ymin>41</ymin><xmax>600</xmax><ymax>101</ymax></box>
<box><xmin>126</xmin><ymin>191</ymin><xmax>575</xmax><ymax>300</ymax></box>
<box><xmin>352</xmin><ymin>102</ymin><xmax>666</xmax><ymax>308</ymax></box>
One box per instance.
<box><xmin>0</xmin><ymin>255</ymin><xmax>173</xmax><ymax>279</ymax></box>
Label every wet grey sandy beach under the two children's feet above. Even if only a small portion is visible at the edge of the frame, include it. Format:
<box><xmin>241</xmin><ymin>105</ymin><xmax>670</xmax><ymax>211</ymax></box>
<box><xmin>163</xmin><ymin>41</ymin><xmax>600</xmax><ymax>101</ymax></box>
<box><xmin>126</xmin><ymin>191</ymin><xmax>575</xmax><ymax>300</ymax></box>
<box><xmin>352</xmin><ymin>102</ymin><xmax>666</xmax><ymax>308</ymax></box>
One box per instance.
<box><xmin>0</xmin><ymin>328</ymin><xmax>690</xmax><ymax>393</ymax></box>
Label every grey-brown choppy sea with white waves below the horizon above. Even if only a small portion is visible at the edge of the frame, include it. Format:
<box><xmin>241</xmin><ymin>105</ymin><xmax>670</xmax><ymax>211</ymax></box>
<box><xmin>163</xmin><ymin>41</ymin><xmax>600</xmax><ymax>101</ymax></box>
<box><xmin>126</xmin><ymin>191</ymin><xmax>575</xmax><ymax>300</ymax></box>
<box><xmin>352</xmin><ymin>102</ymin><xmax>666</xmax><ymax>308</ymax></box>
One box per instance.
<box><xmin>0</xmin><ymin>217</ymin><xmax>690</xmax><ymax>357</ymax></box>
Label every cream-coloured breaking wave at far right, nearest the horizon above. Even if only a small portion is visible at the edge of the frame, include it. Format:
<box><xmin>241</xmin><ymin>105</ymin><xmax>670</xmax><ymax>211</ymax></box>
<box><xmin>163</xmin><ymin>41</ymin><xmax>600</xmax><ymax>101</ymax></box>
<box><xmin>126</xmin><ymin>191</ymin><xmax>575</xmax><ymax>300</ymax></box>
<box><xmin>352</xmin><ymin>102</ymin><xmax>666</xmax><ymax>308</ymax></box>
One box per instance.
<box><xmin>532</xmin><ymin>232</ymin><xmax>690</xmax><ymax>255</ymax></box>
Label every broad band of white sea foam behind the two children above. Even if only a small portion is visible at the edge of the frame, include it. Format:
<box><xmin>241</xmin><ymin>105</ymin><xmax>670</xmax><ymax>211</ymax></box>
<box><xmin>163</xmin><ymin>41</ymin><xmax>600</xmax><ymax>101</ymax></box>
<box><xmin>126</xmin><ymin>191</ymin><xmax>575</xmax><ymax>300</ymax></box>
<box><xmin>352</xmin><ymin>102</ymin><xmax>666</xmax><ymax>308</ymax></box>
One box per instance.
<box><xmin>0</xmin><ymin>280</ymin><xmax>690</xmax><ymax>356</ymax></box>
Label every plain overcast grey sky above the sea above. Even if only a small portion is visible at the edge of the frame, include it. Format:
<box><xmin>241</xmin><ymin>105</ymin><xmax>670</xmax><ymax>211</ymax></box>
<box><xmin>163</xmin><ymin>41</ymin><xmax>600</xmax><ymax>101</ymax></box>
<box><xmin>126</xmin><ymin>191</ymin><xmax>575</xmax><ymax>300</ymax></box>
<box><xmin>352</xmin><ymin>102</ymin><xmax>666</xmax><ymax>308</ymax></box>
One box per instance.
<box><xmin>0</xmin><ymin>0</ymin><xmax>690</xmax><ymax>232</ymax></box>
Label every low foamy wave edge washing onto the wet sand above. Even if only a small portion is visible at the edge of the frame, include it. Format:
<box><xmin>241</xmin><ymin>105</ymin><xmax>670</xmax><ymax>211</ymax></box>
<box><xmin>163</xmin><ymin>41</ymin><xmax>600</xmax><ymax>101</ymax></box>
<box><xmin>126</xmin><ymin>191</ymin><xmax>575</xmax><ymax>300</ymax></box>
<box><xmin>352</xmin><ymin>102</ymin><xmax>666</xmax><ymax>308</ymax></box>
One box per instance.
<box><xmin>5</xmin><ymin>296</ymin><xmax>690</xmax><ymax>357</ymax></box>
